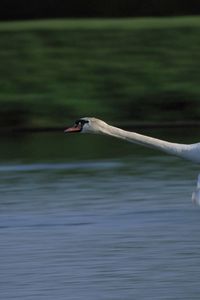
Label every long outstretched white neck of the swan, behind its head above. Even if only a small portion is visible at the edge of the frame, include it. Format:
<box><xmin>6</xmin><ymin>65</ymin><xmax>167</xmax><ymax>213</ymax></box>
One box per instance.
<box><xmin>100</xmin><ymin>124</ymin><xmax>200</xmax><ymax>163</ymax></box>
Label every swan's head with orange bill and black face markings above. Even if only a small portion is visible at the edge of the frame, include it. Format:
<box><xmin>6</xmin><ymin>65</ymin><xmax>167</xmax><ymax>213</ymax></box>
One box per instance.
<box><xmin>64</xmin><ymin>117</ymin><xmax>107</xmax><ymax>133</ymax></box>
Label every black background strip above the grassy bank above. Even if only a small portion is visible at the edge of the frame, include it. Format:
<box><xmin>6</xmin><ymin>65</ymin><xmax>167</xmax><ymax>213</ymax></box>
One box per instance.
<box><xmin>0</xmin><ymin>0</ymin><xmax>200</xmax><ymax>20</ymax></box>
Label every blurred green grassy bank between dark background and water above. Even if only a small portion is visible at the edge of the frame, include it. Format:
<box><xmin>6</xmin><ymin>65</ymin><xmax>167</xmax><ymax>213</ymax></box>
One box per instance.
<box><xmin>0</xmin><ymin>17</ymin><xmax>200</xmax><ymax>127</ymax></box>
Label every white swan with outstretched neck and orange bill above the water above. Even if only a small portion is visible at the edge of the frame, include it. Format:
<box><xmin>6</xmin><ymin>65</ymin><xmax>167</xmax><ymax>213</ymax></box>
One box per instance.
<box><xmin>64</xmin><ymin>117</ymin><xmax>200</xmax><ymax>204</ymax></box>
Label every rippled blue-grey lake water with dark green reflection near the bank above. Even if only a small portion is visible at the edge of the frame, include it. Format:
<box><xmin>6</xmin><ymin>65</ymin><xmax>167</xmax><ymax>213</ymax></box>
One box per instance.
<box><xmin>0</xmin><ymin>130</ymin><xmax>200</xmax><ymax>300</ymax></box>
